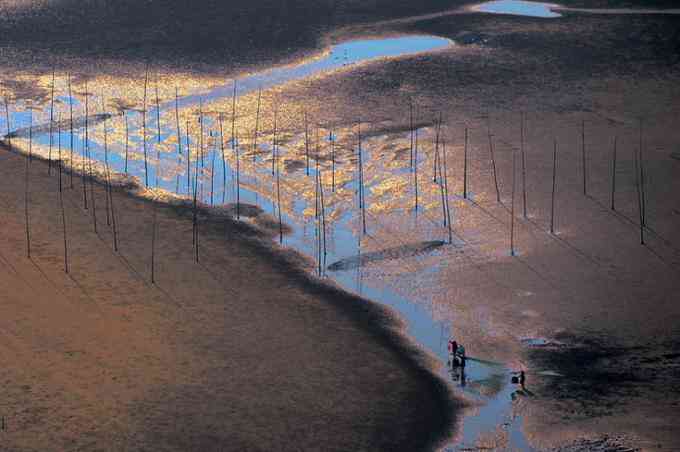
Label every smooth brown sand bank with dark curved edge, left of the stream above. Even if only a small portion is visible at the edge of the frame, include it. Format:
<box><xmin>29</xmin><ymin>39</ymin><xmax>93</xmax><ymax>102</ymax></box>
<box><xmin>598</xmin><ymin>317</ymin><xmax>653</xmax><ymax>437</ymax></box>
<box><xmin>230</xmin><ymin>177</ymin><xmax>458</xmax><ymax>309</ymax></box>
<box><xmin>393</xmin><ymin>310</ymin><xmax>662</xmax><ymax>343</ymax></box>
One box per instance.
<box><xmin>0</xmin><ymin>148</ymin><xmax>455</xmax><ymax>451</ymax></box>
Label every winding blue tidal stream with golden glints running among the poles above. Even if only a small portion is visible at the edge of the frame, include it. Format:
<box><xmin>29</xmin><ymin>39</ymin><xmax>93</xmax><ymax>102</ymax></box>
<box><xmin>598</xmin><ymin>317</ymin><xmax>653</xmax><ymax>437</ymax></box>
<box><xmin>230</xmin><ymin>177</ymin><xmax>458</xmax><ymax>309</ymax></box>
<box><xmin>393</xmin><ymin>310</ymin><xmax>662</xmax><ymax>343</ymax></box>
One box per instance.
<box><xmin>0</xmin><ymin>36</ymin><xmax>526</xmax><ymax>449</ymax></box>
